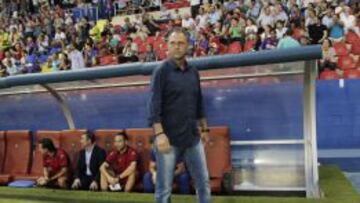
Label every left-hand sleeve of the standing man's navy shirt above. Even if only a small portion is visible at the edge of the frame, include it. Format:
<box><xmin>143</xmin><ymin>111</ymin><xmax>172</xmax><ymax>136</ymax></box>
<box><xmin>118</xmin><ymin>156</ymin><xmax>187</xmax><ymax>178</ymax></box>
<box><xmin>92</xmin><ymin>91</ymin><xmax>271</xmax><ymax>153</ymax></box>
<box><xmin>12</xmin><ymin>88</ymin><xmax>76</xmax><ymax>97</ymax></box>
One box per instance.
<box><xmin>148</xmin><ymin>66</ymin><xmax>163</xmax><ymax>126</ymax></box>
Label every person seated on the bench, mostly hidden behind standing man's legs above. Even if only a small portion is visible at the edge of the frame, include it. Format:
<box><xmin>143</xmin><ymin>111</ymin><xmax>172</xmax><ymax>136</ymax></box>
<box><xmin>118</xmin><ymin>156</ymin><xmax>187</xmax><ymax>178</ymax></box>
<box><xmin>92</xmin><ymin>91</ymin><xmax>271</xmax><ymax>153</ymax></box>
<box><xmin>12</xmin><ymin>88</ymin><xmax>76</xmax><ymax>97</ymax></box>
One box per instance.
<box><xmin>143</xmin><ymin>139</ymin><xmax>190</xmax><ymax>194</ymax></box>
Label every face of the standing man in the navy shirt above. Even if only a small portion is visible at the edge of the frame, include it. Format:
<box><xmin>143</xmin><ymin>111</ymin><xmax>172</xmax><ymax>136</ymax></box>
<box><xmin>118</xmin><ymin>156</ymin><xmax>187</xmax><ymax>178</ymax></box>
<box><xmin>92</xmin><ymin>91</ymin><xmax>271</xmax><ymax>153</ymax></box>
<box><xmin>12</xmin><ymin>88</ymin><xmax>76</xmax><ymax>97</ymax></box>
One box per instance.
<box><xmin>168</xmin><ymin>32</ymin><xmax>189</xmax><ymax>60</ymax></box>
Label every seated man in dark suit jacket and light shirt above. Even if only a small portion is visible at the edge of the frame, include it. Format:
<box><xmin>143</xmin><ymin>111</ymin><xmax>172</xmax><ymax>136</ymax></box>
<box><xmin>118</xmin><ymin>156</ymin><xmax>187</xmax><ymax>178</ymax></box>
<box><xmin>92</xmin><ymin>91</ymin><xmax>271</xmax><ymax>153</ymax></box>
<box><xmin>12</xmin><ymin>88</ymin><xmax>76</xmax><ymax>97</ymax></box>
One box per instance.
<box><xmin>72</xmin><ymin>131</ymin><xmax>106</xmax><ymax>190</ymax></box>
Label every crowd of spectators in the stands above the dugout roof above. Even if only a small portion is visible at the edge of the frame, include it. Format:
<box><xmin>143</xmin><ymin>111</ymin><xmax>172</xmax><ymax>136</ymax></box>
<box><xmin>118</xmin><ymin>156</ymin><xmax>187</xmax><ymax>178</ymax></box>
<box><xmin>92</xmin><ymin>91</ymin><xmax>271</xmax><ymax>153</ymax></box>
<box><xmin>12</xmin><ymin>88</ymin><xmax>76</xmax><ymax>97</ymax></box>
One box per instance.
<box><xmin>0</xmin><ymin>0</ymin><xmax>360</xmax><ymax>79</ymax></box>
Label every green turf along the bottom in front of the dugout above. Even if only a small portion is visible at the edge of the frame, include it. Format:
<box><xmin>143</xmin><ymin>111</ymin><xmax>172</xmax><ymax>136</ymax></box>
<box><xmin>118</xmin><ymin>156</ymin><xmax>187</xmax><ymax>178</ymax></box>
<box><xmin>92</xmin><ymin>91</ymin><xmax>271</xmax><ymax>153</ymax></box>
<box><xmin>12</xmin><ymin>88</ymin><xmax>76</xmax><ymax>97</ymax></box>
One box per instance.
<box><xmin>0</xmin><ymin>166</ymin><xmax>360</xmax><ymax>203</ymax></box>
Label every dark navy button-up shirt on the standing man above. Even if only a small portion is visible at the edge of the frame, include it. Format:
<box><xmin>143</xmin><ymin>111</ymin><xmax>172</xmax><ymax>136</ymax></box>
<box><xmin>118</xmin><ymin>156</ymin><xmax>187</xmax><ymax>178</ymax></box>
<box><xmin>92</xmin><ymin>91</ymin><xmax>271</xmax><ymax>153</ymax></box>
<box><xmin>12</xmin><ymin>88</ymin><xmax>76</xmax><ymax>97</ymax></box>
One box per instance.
<box><xmin>148</xmin><ymin>60</ymin><xmax>205</xmax><ymax>147</ymax></box>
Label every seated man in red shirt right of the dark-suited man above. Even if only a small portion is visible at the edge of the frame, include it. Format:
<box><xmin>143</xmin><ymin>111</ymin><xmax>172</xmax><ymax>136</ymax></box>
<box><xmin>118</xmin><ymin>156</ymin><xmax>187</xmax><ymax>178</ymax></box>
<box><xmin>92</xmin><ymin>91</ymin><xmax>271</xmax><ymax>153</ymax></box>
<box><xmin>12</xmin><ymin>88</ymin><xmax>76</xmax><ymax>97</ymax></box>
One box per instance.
<box><xmin>100</xmin><ymin>133</ymin><xmax>137</xmax><ymax>192</ymax></box>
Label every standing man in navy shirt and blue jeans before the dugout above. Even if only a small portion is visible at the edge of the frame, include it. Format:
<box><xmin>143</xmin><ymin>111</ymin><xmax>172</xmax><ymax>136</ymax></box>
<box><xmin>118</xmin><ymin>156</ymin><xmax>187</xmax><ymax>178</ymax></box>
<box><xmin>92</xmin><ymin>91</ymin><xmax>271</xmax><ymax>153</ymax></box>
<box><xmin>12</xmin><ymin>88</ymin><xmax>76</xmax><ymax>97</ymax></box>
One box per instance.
<box><xmin>149</xmin><ymin>28</ymin><xmax>211</xmax><ymax>203</ymax></box>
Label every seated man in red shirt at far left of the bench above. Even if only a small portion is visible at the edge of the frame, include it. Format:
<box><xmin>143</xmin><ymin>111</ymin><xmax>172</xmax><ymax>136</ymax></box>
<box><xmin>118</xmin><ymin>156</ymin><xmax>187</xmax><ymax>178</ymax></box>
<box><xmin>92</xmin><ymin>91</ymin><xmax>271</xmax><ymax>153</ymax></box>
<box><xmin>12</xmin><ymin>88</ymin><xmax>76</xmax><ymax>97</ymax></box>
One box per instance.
<box><xmin>37</xmin><ymin>138</ymin><xmax>70</xmax><ymax>189</ymax></box>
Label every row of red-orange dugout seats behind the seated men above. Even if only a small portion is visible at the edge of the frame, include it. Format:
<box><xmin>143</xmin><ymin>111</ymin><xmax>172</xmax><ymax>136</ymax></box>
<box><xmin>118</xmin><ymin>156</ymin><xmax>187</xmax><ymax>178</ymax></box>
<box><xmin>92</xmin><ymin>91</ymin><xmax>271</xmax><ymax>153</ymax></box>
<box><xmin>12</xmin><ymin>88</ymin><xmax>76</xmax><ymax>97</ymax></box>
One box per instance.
<box><xmin>0</xmin><ymin>127</ymin><xmax>231</xmax><ymax>193</ymax></box>
